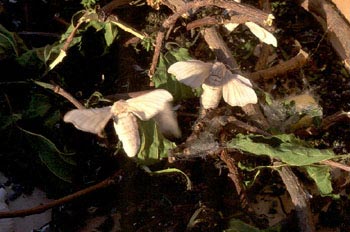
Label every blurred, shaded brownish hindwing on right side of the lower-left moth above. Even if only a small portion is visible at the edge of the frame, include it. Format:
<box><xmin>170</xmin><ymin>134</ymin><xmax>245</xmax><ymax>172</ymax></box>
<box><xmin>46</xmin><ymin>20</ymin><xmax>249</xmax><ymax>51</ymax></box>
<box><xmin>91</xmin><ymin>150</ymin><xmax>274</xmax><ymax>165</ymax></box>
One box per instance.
<box><xmin>154</xmin><ymin>103</ymin><xmax>181</xmax><ymax>139</ymax></box>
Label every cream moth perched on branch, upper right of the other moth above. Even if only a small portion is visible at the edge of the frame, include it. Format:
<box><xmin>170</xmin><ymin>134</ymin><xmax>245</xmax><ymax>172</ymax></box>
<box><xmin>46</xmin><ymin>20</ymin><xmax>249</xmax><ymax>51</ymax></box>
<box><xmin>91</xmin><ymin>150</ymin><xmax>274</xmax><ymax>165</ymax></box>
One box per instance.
<box><xmin>168</xmin><ymin>60</ymin><xmax>258</xmax><ymax>109</ymax></box>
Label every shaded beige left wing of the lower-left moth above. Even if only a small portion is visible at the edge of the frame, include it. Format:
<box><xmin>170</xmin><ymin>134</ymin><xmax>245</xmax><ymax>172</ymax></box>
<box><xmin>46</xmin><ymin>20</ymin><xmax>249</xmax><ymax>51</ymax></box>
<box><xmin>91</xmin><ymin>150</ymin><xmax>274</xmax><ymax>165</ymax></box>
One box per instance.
<box><xmin>63</xmin><ymin>106</ymin><xmax>112</xmax><ymax>134</ymax></box>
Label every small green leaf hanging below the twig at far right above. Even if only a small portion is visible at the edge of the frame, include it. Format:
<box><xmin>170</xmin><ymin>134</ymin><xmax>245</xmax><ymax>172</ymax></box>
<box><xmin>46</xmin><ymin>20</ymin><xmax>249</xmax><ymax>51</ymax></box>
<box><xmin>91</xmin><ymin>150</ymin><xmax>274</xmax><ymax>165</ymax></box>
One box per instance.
<box><xmin>305</xmin><ymin>166</ymin><xmax>333</xmax><ymax>196</ymax></box>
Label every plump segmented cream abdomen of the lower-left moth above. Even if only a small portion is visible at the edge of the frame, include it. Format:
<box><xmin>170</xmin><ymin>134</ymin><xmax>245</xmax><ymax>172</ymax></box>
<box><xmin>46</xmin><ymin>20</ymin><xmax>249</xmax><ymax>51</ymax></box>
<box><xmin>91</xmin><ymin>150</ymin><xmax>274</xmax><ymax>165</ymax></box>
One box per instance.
<box><xmin>113</xmin><ymin>112</ymin><xmax>140</xmax><ymax>157</ymax></box>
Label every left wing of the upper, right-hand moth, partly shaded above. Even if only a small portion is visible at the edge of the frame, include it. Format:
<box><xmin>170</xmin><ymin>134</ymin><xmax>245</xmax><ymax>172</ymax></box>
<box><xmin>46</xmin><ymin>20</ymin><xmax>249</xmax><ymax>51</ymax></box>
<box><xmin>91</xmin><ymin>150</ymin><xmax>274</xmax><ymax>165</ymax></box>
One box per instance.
<box><xmin>168</xmin><ymin>60</ymin><xmax>213</xmax><ymax>88</ymax></box>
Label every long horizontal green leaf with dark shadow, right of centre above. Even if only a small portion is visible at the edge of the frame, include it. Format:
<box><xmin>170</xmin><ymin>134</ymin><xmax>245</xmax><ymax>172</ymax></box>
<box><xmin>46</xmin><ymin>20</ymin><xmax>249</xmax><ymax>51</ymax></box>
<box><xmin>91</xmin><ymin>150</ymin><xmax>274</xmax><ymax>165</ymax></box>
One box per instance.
<box><xmin>227</xmin><ymin>134</ymin><xmax>334</xmax><ymax>166</ymax></box>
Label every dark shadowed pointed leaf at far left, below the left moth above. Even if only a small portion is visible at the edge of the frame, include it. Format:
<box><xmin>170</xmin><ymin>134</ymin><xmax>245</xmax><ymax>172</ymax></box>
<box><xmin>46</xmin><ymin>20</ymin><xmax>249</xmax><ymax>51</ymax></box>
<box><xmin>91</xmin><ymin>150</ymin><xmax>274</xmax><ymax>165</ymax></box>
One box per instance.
<box><xmin>20</xmin><ymin>128</ymin><xmax>74</xmax><ymax>183</ymax></box>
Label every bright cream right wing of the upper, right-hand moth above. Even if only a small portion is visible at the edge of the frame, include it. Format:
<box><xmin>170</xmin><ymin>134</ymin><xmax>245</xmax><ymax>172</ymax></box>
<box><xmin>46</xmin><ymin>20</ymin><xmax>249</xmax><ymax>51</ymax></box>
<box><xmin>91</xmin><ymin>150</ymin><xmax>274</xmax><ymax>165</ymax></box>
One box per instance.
<box><xmin>222</xmin><ymin>72</ymin><xmax>258</xmax><ymax>106</ymax></box>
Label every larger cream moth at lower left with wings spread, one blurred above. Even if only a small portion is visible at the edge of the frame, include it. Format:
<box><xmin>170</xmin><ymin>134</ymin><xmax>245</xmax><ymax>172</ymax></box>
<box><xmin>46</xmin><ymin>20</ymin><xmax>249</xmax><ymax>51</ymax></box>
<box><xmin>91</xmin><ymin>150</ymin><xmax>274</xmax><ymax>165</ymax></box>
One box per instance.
<box><xmin>63</xmin><ymin>89</ymin><xmax>181</xmax><ymax>157</ymax></box>
